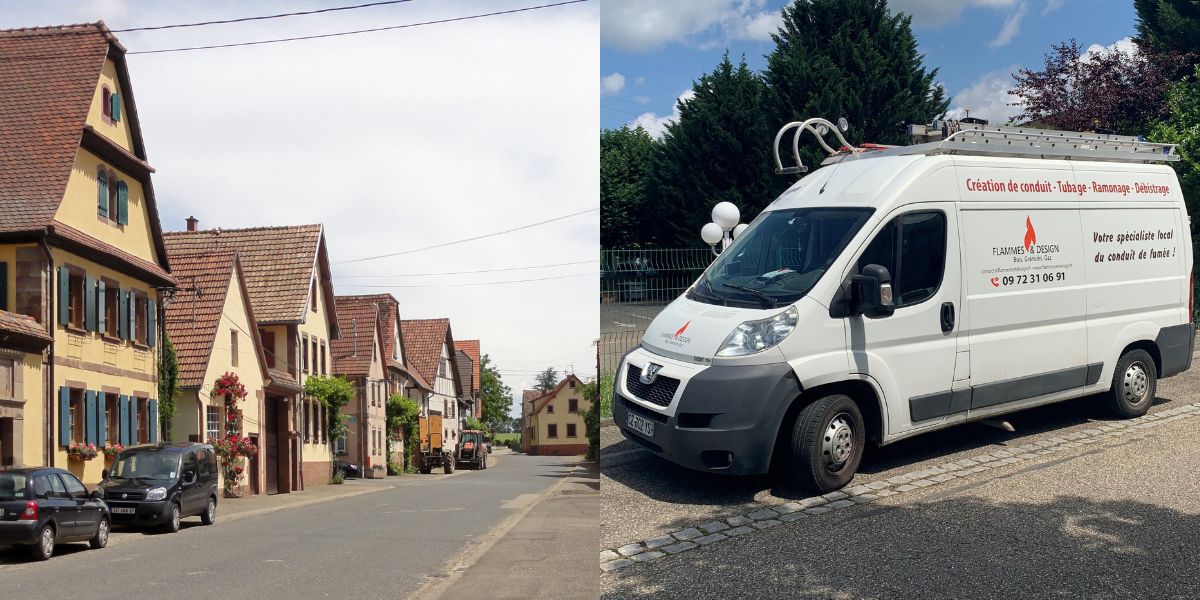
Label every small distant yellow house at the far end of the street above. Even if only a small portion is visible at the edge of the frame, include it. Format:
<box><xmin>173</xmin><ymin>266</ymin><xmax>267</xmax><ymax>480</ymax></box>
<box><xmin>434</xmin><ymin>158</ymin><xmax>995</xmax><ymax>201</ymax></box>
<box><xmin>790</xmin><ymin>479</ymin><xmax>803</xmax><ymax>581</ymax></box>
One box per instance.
<box><xmin>522</xmin><ymin>374</ymin><xmax>592</xmax><ymax>456</ymax></box>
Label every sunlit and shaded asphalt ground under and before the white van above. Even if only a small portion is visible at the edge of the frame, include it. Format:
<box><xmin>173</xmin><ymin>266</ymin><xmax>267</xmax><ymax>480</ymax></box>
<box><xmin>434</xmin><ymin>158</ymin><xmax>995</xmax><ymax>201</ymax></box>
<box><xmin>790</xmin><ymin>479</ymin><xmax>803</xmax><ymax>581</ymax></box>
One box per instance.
<box><xmin>601</xmin><ymin>362</ymin><xmax>1200</xmax><ymax>599</ymax></box>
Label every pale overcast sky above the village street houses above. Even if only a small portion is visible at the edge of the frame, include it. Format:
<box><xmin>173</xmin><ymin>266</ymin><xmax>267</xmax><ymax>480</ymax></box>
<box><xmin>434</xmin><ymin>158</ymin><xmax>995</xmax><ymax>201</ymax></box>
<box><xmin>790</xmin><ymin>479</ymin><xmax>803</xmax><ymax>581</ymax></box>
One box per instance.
<box><xmin>0</xmin><ymin>0</ymin><xmax>600</xmax><ymax>414</ymax></box>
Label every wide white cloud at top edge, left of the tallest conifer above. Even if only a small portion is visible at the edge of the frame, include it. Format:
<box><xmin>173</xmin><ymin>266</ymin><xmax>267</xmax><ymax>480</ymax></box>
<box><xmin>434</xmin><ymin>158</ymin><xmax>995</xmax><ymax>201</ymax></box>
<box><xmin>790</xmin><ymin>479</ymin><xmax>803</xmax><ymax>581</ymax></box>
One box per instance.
<box><xmin>600</xmin><ymin>0</ymin><xmax>781</xmax><ymax>53</ymax></box>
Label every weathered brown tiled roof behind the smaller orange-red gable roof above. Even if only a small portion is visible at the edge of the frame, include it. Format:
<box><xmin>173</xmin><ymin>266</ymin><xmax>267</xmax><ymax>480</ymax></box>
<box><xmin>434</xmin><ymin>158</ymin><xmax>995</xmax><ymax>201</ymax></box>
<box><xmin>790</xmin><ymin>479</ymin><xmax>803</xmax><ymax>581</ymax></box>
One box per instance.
<box><xmin>164</xmin><ymin>224</ymin><xmax>335</xmax><ymax>323</ymax></box>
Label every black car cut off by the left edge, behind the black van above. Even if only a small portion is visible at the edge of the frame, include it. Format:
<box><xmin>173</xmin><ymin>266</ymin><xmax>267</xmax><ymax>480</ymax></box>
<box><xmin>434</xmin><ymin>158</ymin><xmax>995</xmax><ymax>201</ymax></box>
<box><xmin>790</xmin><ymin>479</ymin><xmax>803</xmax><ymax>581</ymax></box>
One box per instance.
<box><xmin>0</xmin><ymin>467</ymin><xmax>112</xmax><ymax>560</ymax></box>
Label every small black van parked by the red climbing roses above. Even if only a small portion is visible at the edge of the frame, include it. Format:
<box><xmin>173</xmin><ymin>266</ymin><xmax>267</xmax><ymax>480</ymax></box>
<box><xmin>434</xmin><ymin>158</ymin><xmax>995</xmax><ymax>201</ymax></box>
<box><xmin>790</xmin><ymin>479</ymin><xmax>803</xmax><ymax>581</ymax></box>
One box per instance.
<box><xmin>96</xmin><ymin>442</ymin><xmax>217</xmax><ymax>532</ymax></box>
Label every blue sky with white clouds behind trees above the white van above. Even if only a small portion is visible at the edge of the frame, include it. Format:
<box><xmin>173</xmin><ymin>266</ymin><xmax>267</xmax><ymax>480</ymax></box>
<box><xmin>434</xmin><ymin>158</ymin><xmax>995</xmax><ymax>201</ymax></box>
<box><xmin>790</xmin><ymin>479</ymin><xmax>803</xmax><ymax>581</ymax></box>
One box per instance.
<box><xmin>600</xmin><ymin>0</ymin><xmax>1135</xmax><ymax>136</ymax></box>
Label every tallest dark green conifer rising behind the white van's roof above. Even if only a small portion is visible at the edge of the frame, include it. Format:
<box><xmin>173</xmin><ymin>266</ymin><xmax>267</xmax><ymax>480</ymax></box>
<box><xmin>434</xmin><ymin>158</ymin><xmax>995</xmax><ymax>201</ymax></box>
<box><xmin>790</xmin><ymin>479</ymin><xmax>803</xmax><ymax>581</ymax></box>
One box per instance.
<box><xmin>763</xmin><ymin>0</ymin><xmax>949</xmax><ymax>169</ymax></box>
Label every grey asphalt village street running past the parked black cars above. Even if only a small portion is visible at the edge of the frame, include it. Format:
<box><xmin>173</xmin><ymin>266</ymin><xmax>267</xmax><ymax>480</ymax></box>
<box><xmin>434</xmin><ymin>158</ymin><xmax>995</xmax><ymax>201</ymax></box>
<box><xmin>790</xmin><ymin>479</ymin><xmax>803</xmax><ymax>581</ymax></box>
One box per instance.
<box><xmin>0</xmin><ymin>455</ymin><xmax>577</xmax><ymax>600</ymax></box>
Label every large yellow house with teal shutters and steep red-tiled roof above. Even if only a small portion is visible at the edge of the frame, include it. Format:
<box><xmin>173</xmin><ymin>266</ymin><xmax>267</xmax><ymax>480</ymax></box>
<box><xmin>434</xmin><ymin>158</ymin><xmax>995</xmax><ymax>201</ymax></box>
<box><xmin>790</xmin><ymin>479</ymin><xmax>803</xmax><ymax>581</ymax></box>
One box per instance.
<box><xmin>0</xmin><ymin>24</ymin><xmax>174</xmax><ymax>484</ymax></box>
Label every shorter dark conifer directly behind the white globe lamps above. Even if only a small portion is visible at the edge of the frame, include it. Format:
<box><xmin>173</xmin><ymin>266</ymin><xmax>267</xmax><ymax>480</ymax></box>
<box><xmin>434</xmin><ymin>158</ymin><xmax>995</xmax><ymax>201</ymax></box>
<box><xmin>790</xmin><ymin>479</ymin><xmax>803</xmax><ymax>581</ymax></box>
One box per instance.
<box><xmin>648</xmin><ymin>53</ymin><xmax>777</xmax><ymax>247</ymax></box>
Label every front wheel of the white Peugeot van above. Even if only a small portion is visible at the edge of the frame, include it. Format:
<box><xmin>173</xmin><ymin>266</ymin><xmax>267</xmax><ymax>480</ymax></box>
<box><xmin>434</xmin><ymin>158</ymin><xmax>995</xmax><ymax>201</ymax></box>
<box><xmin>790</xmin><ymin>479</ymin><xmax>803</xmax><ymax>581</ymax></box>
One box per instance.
<box><xmin>791</xmin><ymin>394</ymin><xmax>866</xmax><ymax>493</ymax></box>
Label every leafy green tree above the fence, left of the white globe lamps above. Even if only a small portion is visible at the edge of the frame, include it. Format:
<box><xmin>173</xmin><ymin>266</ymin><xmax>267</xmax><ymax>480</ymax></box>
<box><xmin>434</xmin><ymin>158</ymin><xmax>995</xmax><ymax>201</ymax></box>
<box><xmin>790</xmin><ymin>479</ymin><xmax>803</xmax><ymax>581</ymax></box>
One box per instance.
<box><xmin>600</xmin><ymin>125</ymin><xmax>656</xmax><ymax>248</ymax></box>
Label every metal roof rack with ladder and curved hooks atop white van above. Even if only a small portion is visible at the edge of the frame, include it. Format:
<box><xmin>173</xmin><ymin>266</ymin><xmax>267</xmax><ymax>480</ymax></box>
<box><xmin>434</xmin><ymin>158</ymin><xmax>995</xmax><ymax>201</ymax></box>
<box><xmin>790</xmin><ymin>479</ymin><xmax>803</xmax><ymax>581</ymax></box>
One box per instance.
<box><xmin>774</xmin><ymin>119</ymin><xmax>1180</xmax><ymax>174</ymax></box>
